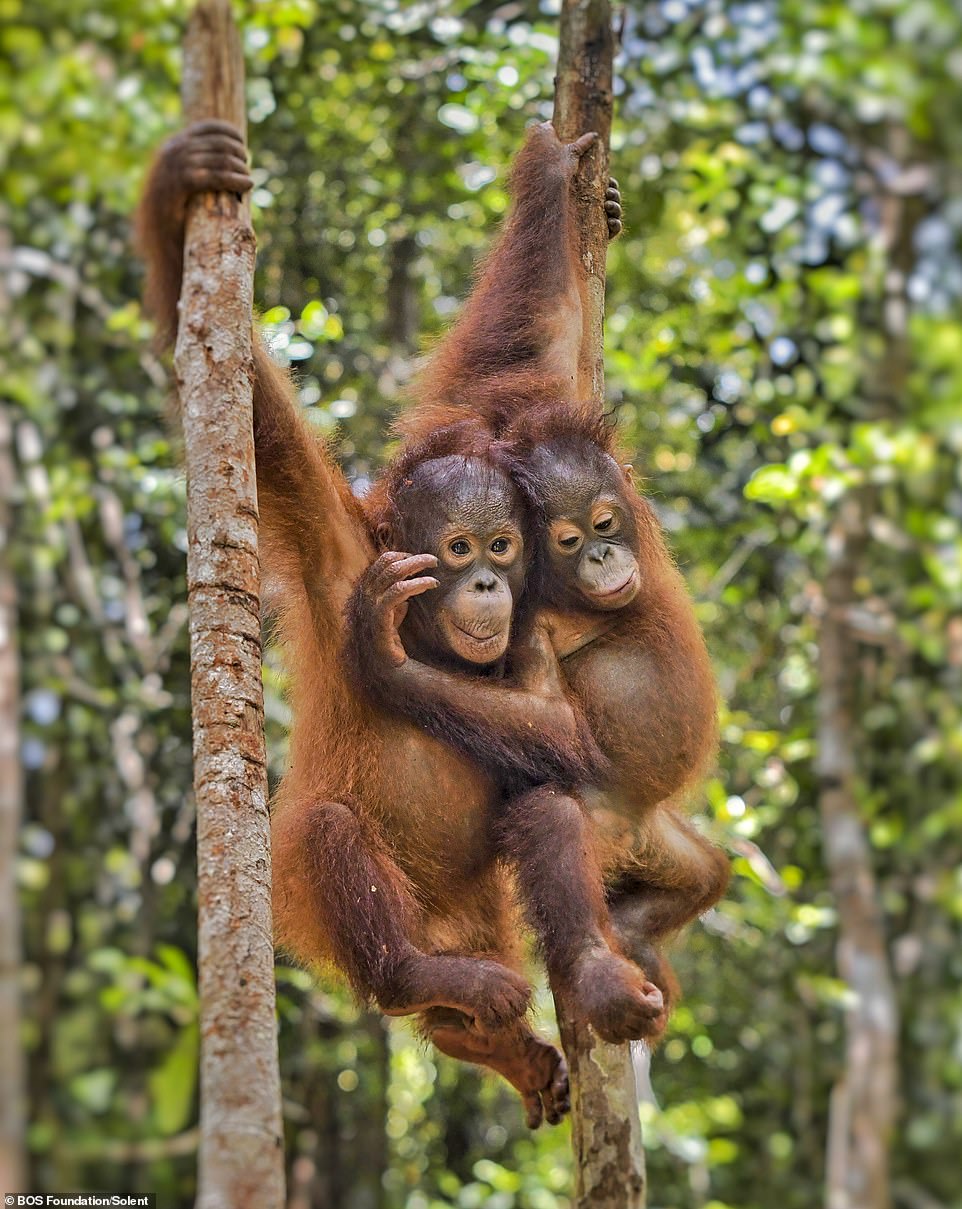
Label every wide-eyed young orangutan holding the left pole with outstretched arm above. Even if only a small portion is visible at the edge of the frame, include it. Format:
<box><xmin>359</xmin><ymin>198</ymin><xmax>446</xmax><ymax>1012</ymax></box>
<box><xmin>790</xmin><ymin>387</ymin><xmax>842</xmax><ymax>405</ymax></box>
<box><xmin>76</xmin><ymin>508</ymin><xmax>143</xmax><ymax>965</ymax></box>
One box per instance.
<box><xmin>138</xmin><ymin>121</ymin><xmax>590</xmax><ymax>1127</ymax></box>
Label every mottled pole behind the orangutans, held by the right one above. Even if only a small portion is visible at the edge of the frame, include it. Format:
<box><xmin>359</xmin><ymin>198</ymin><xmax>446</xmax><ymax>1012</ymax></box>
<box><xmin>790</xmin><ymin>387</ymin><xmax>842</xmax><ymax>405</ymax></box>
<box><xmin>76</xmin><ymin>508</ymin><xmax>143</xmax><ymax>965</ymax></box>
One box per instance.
<box><xmin>554</xmin><ymin>0</ymin><xmax>645</xmax><ymax>1209</ymax></box>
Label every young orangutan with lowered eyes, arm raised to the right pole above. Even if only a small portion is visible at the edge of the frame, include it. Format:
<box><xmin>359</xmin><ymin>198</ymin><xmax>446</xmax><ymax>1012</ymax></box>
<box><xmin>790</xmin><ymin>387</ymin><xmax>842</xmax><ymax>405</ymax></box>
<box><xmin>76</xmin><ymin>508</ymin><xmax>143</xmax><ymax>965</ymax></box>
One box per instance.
<box><xmin>367</xmin><ymin>123</ymin><xmax>729</xmax><ymax>1040</ymax></box>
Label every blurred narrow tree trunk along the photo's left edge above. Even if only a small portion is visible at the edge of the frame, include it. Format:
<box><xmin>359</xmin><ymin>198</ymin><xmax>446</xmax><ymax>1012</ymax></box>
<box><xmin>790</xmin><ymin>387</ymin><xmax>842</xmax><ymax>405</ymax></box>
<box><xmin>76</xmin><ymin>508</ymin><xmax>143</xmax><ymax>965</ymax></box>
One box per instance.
<box><xmin>0</xmin><ymin>406</ymin><xmax>25</xmax><ymax>1193</ymax></box>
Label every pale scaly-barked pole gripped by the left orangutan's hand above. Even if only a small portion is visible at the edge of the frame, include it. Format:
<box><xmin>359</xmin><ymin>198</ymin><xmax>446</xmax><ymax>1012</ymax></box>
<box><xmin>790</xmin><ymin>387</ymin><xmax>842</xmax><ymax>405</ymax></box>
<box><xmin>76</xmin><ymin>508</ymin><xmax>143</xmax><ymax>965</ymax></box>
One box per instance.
<box><xmin>174</xmin><ymin>0</ymin><xmax>284</xmax><ymax>1209</ymax></box>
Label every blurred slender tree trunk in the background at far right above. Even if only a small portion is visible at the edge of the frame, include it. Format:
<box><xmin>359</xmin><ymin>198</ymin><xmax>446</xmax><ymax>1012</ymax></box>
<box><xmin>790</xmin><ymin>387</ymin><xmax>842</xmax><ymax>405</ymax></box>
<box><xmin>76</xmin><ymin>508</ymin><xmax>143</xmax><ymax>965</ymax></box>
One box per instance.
<box><xmin>817</xmin><ymin>120</ymin><xmax>922</xmax><ymax>1209</ymax></box>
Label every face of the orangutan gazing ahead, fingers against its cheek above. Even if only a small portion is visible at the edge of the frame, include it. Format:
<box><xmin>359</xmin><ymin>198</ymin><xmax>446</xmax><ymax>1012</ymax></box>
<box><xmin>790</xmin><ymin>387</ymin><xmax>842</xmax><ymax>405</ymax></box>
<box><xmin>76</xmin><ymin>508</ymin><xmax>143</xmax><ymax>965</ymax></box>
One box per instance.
<box><xmin>379</xmin><ymin>458</ymin><xmax>525</xmax><ymax>666</ymax></box>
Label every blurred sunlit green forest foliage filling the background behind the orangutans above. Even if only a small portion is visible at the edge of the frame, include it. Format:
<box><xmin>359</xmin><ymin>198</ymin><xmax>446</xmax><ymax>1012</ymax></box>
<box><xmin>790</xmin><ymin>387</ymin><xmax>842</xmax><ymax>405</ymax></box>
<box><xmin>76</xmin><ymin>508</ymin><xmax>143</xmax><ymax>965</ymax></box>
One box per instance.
<box><xmin>7</xmin><ymin>0</ymin><xmax>962</xmax><ymax>1209</ymax></box>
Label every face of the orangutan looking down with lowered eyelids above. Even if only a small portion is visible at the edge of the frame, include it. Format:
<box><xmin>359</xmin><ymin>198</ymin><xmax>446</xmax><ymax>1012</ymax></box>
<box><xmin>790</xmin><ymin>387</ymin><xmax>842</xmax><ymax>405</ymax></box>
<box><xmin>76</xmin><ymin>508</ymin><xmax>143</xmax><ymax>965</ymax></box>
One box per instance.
<box><xmin>532</xmin><ymin>446</ymin><xmax>641</xmax><ymax>612</ymax></box>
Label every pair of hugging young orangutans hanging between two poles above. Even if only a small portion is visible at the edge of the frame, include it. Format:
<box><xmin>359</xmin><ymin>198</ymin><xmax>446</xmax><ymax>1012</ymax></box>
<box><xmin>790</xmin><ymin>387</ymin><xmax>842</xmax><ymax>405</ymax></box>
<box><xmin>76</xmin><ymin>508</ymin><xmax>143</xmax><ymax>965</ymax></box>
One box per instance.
<box><xmin>139</xmin><ymin>108</ymin><xmax>726</xmax><ymax>1126</ymax></box>
